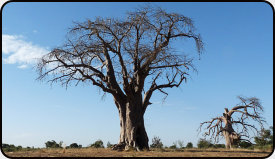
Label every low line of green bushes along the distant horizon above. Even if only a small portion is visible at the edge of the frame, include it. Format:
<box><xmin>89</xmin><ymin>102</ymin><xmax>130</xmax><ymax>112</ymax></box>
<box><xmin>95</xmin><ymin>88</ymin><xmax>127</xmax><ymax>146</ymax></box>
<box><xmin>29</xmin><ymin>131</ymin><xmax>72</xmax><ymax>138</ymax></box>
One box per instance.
<box><xmin>2</xmin><ymin>126</ymin><xmax>273</xmax><ymax>152</ymax></box>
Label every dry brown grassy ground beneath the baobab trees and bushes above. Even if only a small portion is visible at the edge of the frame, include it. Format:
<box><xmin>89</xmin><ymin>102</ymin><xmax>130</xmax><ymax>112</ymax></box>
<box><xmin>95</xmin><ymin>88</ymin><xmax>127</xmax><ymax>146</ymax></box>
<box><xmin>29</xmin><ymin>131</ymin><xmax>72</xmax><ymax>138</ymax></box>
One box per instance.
<box><xmin>5</xmin><ymin>148</ymin><xmax>272</xmax><ymax>157</ymax></box>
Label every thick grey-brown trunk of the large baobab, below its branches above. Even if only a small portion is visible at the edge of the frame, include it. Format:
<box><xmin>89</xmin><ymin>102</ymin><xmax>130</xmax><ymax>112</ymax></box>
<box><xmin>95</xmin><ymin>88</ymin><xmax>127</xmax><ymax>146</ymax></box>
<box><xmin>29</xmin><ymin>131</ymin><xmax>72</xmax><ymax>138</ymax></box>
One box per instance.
<box><xmin>113</xmin><ymin>97</ymin><xmax>149</xmax><ymax>151</ymax></box>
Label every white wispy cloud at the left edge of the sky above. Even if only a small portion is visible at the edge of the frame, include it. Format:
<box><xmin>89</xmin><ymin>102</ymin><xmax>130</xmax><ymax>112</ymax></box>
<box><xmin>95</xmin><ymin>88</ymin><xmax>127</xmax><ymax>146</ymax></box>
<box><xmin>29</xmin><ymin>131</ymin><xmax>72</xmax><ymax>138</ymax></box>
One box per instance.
<box><xmin>2</xmin><ymin>34</ymin><xmax>49</xmax><ymax>69</ymax></box>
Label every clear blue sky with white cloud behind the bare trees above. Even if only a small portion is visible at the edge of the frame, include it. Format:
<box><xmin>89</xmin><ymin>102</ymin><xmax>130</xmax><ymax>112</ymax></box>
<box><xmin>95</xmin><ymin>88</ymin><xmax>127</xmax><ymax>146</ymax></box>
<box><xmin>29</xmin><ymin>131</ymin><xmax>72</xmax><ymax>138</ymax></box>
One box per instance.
<box><xmin>2</xmin><ymin>2</ymin><xmax>273</xmax><ymax>147</ymax></box>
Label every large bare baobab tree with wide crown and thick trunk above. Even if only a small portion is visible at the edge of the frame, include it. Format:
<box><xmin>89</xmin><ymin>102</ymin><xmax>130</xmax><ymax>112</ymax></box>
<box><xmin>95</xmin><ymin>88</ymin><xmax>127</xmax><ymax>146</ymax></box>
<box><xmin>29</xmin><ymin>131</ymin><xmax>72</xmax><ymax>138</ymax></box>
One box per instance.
<box><xmin>36</xmin><ymin>7</ymin><xmax>203</xmax><ymax>150</ymax></box>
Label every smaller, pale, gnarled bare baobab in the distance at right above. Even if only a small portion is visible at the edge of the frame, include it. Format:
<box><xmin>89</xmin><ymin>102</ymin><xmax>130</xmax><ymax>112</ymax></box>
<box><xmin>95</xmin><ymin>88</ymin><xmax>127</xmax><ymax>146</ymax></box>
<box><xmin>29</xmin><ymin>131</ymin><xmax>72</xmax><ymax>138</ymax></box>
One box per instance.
<box><xmin>199</xmin><ymin>96</ymin><xmax>265</xmax><ymax>149</ymax></box>
